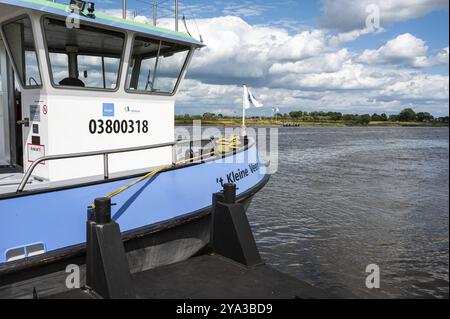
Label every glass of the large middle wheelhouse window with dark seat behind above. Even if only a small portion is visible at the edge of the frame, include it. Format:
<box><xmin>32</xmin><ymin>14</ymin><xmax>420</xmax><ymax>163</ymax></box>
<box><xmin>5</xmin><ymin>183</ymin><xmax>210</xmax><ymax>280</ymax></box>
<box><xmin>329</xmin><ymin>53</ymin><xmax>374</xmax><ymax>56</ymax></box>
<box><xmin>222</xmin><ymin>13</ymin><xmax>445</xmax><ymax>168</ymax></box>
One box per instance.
<box><xmin>44</xmin><ymin>18</ymin><xmax>125</xmax><ymax>90</ymax></box>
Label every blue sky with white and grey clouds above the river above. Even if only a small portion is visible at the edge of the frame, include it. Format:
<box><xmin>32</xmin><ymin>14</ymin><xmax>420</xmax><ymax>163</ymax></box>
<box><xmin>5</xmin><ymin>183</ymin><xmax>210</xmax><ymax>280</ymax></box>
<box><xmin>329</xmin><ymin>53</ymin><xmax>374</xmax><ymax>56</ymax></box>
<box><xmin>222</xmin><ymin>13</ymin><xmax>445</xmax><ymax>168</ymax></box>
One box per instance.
<box><xmin>97</xmin><ymin>0</ymin><xmax>449</xmax><ymax>115</ymax></box>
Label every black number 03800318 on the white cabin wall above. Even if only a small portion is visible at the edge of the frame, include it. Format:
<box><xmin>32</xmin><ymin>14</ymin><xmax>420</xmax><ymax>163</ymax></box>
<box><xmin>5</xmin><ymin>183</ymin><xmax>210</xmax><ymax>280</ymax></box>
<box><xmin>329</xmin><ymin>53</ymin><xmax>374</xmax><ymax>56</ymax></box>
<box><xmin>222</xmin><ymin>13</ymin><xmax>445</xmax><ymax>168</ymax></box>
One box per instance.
<box><xmin>89</xmin><ymin>120</ymin><xmax>149</xmax><ymax>134</ymax></box>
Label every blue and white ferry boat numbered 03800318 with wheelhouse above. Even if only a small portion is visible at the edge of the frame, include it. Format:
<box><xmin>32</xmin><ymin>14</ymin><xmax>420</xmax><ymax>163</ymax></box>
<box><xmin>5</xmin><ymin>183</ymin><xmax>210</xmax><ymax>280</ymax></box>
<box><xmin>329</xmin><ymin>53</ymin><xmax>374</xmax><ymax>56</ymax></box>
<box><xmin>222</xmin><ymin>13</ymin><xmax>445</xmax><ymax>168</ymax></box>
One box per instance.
<box><xmin>0</xmin><ymin>0</ymin><xmax>269</xmax><ymax>298</ymax></box>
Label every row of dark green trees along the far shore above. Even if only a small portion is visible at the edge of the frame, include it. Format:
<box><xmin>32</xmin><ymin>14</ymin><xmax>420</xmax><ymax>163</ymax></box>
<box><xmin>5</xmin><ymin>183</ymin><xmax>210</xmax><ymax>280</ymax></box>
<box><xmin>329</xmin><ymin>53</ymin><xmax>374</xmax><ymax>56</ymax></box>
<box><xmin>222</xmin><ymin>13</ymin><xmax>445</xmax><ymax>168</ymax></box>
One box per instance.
<box><xmin>176</xmin><ymin>108</ymin><xmax>449</xmax><ymax>125</ymax></box>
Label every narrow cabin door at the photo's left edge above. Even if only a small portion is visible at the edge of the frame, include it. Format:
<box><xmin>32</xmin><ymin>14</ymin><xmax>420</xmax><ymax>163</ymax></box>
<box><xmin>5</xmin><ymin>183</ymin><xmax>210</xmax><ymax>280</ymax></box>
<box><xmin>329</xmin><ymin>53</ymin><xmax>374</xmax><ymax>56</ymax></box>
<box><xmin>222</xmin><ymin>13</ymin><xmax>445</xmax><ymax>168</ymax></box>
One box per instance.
<box><xmin>0</xmin><ymin>39</ymin><xmax>23</xmax><ymax>170</ymax></box>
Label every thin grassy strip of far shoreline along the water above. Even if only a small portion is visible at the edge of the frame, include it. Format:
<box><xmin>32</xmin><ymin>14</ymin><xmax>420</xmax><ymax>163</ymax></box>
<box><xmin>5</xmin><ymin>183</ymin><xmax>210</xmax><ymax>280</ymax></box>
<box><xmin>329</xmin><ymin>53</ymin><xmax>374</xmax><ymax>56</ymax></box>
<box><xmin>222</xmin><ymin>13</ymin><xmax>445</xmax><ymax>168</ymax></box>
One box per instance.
<box><xmin>175</xmin><ymin>119</ymin><xmax>449</xmax><ymax>127</ymax></box>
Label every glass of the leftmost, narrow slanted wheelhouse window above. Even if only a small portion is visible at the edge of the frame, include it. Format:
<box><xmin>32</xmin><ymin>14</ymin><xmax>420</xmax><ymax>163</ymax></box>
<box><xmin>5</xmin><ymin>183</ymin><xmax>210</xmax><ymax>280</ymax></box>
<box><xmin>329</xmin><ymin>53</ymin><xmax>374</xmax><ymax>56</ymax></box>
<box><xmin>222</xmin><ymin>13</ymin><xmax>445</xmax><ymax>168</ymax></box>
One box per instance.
<box><xmin>2</xmin><ymin>17</ymin><xmax>42</xmax><ymax>88</ymax></box>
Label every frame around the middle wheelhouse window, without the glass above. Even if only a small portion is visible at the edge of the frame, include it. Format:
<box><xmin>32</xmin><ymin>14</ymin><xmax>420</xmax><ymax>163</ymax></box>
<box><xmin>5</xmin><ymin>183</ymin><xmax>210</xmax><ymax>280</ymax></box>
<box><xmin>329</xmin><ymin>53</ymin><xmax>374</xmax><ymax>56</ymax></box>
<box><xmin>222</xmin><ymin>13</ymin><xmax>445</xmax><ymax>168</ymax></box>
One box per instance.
<box><xmin>40</xmin><ymin>14</ymin><xmax>128</xmax><ymax>92</ymax></box>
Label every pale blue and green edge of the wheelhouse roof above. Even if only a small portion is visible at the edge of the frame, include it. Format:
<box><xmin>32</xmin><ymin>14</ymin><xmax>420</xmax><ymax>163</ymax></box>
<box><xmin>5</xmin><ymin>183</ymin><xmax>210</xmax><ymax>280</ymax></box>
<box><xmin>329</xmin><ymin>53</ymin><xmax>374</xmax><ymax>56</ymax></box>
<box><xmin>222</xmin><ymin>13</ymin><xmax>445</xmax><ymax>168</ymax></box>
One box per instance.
<box><xmin>0</xmin><ymin>0</ymin><xmax>204</xmax><ymax>47</ymax></box>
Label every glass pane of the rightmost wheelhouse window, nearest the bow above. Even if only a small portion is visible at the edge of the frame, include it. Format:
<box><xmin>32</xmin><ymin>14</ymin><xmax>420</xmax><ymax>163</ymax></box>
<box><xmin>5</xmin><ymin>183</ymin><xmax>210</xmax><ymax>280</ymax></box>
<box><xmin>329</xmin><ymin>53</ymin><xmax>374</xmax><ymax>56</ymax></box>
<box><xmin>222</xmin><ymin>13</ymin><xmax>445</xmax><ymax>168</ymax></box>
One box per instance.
<box><xmin>127</xmin><ymin>37</ymin><xmax>190</xmax><ymax>94</ymax></box>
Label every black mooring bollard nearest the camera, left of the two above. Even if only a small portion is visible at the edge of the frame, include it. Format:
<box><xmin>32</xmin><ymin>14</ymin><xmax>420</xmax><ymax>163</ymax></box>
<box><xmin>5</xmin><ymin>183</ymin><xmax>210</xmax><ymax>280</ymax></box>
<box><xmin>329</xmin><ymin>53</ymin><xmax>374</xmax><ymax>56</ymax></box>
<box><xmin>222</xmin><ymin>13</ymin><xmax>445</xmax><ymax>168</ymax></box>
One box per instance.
<box><xmin>86</xmin><ymin>198</ymin><xmax>136</xmax><ymax>299</ymax></box>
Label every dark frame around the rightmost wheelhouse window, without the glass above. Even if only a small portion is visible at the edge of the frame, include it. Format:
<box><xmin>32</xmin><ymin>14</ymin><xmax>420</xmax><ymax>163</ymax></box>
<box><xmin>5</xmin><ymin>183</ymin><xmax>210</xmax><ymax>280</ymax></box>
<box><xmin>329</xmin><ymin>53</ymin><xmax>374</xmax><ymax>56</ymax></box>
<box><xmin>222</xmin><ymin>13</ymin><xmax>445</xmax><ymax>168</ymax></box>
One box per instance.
<box><xmin>125</xmin><ymin>32</ymin><xmax>195</xmax><ymax>96</ymax></box>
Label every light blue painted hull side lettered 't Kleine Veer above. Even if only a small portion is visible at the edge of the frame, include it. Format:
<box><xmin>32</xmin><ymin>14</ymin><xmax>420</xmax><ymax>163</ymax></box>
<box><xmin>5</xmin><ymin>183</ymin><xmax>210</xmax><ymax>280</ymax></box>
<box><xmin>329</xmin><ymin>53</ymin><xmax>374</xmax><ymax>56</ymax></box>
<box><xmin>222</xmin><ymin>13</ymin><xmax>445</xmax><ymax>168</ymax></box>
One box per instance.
<box><xmin>0</xmin><ymin>146</ymin><xmax>266</xmax><ymax>265</ymax></box>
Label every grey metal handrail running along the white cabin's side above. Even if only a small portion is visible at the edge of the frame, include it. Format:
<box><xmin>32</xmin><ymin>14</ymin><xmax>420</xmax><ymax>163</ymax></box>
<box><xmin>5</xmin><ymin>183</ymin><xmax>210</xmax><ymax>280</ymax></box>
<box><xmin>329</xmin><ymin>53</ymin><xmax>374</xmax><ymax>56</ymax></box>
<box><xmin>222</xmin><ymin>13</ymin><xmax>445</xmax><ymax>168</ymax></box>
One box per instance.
<box><xmin>16</xmin><ymin>142</ymin><xmax>177</xmax><ymax>193</ymax></box>
